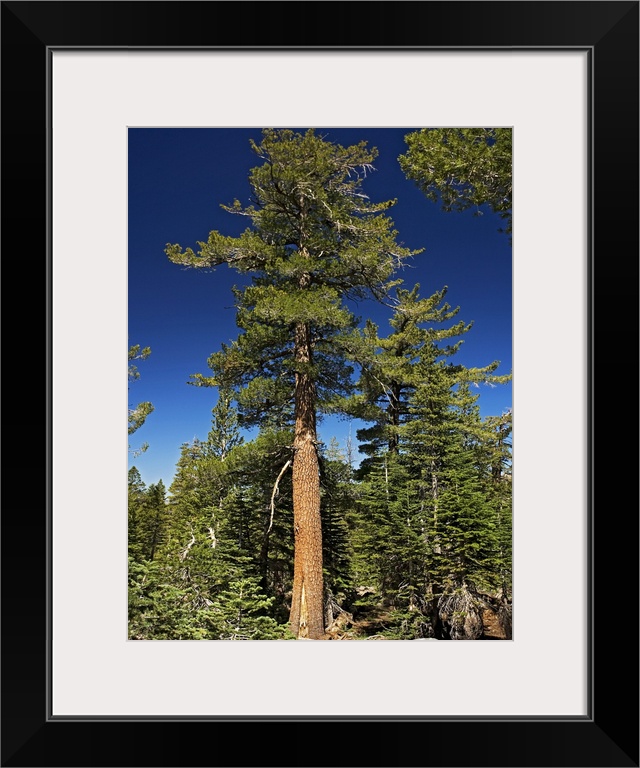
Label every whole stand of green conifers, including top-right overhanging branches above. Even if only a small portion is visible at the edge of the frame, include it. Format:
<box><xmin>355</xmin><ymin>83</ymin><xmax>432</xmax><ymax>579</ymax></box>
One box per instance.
<box><xmin>128</xmin><ymin>128</ymin><xmax>513</xmax><ymax>641</ymax></box>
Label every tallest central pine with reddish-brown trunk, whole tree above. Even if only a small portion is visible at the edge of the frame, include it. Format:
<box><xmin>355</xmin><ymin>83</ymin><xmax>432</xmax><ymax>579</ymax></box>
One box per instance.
<box><xmin>166</xmin><ymin>129</ymin><xmax>412</xmax><ymax>639</ymax></box>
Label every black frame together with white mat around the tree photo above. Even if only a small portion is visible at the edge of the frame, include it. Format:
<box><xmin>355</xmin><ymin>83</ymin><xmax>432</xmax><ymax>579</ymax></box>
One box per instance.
<box><xmin>2</xmin><ymin>2</ymin><xmax>638</xmax><ymax>767</ymax></box>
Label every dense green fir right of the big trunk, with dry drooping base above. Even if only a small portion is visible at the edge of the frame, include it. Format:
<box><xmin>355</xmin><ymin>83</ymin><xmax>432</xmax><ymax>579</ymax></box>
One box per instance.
<box><xmin>408</xmin><ymin>376</ymin><xmax>511</xmax><ymax>639</ymax></box>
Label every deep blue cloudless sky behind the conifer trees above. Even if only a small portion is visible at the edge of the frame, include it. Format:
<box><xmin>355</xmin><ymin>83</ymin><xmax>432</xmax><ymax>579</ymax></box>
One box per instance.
<box><xmin>128</xmin><ymin>126</ymin><xmax>512</xmax><ymax>488</ymax></box>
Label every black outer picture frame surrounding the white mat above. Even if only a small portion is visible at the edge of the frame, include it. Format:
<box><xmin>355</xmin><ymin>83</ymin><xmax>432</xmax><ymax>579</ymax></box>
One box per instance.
<box><xmin>1</xmin><ymin>0</ymin><xmax>640</xmax><ymax>768</ymax></box>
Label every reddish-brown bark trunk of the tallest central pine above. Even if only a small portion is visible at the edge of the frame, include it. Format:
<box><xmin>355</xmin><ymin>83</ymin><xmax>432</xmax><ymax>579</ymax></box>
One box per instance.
<box><xmin>289</xmin><ymin>323</ymin><xmax>324</xmax><ymax>640</ymax></box>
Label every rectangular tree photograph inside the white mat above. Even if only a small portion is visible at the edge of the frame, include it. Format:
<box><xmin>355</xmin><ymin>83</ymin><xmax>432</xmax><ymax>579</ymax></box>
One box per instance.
<box><xmin>123</xmin><ymin>127</ymin><xmax>513</xmax><ymax>640</ymax></box>
